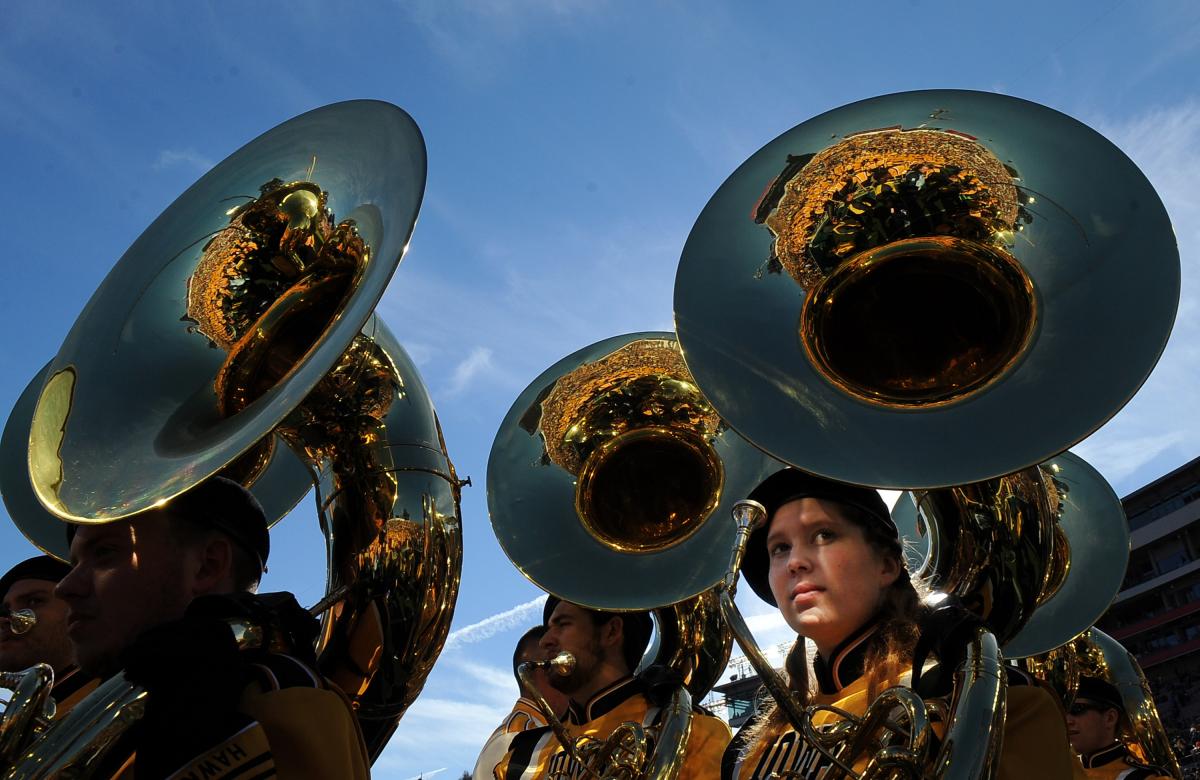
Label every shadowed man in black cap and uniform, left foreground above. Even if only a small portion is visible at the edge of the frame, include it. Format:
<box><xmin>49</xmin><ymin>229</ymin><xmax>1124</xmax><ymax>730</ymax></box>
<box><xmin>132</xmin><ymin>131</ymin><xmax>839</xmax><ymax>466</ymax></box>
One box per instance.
<box><xmin>56</xmin><ymin>476</ymin><xmax>368</xmax><ymax>779</ymax></box>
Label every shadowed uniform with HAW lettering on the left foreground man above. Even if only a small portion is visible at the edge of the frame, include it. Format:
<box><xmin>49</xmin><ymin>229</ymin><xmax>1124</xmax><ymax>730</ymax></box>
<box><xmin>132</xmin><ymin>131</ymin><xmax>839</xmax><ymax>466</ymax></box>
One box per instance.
<box><xmin>100</xmin><ymin>594</ymin><xmax>371</xmax><ymax>780</ymax></box>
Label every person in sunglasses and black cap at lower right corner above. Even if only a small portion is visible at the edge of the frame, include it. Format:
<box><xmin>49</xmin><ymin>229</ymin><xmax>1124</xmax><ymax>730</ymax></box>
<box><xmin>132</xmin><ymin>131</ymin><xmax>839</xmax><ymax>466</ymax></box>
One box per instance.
<box><xmin>1067</xmin><ymin>676</ymin><xmax>1170</xmax><ymax>780</ymax></box>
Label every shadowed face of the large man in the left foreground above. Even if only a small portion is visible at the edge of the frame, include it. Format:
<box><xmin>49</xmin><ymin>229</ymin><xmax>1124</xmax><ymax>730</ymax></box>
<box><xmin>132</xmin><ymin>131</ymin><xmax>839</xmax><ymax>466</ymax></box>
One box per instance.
<box><xmin>56</xmin><ymin>511</ymin><xmax>194</xmax><ymax>674</ymax></box>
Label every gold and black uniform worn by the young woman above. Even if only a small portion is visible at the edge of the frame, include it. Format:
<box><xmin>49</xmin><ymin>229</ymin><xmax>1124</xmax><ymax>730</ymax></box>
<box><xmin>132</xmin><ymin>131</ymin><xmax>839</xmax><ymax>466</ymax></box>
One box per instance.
<box><xmin>721</xmin><ymin>625</ymin><xmax>1076</xmax><ymax>780</ymax></box>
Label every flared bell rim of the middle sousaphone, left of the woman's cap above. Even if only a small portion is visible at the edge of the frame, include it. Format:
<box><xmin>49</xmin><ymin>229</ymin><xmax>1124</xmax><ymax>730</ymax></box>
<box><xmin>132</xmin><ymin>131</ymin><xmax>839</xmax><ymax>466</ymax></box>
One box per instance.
<box><xmin>487</xmin><ymin>331</ymin><xmax>781</xmax><ymax>612</ymax></box>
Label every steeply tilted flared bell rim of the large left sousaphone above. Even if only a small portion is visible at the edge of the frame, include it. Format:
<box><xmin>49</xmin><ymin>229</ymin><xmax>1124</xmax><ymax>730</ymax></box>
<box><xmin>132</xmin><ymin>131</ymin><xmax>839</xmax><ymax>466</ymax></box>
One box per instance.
<box><xmin>23</xmin><ymin>101</ymin><xmax>426</xmax><ymax>522</ymax></box>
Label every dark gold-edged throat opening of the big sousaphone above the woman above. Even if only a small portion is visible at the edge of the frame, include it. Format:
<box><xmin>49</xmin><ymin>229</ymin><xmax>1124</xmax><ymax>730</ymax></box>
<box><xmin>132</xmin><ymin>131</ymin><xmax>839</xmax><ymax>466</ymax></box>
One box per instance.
<box><xmin>800</xmin><ymin>236</ymin><xmax>1037</xmax><ymax>409</ymax></box>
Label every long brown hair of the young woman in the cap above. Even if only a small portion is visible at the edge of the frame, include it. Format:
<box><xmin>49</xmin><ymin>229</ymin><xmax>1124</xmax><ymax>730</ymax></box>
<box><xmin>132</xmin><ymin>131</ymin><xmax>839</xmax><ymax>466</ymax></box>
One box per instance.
<box><xmin>745</xmin><ymin>502</ymin><xmax>924</xmax><ymax>760</ymax></box>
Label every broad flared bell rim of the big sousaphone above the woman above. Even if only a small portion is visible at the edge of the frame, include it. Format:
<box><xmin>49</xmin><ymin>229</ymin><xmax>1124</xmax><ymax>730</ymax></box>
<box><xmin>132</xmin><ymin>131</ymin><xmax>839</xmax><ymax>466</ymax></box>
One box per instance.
<box><xmin>674</xmin><ymin>90</ymin><xmax>1180</xmax><ymax>490</ymax></box>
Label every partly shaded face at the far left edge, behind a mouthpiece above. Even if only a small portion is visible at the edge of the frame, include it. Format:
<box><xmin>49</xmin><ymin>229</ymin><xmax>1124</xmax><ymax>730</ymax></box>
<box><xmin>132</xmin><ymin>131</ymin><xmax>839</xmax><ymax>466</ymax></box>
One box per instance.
<box><xmin>0</xmin><ymin>580</ymin><xmax>74</xmax><ymax>673</ymax></box>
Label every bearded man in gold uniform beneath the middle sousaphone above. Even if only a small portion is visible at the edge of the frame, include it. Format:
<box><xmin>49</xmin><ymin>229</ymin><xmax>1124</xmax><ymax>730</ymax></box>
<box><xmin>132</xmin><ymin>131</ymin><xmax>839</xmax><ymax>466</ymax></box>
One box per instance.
<box><xmin>494</xmin><ymin>596</ymin><xmax>730</xmax><ymax>780</ymax></box>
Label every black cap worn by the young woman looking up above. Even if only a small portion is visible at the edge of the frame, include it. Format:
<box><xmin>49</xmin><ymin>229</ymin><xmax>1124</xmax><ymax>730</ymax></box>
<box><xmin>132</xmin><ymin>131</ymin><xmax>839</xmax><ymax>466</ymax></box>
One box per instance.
<box><xmin>742</xmin><ymin>468</ymin><xmax>900</xmax><ymax>606</ymax></box>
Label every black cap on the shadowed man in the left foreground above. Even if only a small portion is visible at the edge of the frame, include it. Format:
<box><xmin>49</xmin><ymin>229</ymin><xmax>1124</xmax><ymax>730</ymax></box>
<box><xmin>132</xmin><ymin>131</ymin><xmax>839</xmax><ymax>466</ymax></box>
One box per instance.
<box><xmin>67</xmin><ymin>476</ymin><xmax>271</xmax><ymax>570</ymax></box>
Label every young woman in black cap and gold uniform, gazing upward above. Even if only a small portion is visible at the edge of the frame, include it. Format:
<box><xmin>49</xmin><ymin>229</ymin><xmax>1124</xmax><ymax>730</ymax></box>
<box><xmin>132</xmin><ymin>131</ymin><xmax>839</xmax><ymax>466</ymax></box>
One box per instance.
<box><xmin>721</xmin><ymin>469</ymin><xmax>1079</xmax><ymax>780</ymax></box>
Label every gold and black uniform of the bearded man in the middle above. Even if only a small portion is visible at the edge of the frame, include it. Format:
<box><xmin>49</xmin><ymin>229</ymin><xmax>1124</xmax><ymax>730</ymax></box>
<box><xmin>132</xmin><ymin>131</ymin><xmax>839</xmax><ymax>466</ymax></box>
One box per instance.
<box><xmin>494</xmin><ymin>677</ymin><xmax>731</xmax><ymax>780</ymax></box>
